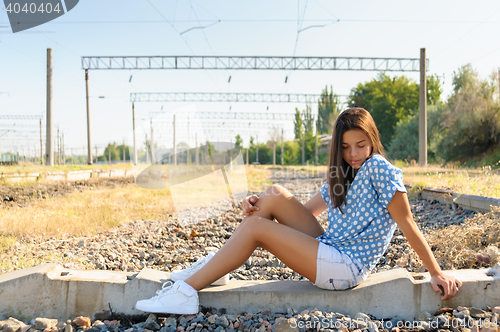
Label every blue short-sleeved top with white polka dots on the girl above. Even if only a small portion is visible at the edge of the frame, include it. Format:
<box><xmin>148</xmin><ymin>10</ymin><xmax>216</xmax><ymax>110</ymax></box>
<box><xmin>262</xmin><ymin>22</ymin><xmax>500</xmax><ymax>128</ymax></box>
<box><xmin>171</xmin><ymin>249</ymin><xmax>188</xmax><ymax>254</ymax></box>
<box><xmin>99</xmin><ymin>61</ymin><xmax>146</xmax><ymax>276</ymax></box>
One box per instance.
<box><xmin>316</xmin><ymin>153</ymin><xmax>406</xmax><ymax>270</ymax></box>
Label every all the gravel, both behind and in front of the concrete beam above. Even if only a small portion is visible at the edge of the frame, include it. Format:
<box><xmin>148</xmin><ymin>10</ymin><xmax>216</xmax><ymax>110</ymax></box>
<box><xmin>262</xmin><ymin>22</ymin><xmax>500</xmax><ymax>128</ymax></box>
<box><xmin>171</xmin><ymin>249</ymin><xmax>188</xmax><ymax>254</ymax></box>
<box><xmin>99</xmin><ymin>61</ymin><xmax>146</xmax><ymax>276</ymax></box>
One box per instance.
<box><xmin>0</xmin><ymin>174</ymin><xmax>492</xmax><ymax>332</ymax></box>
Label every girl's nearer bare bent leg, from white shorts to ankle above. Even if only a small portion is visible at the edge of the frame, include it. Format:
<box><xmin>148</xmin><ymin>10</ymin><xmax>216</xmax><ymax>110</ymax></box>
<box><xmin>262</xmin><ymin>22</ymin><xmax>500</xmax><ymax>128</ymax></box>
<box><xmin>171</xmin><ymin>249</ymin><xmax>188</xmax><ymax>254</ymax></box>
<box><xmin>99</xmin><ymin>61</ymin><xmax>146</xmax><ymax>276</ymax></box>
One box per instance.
<box><xmin>185</xmin><ymin>215</ymin><xmax>319</xmax><ymax>290</ymax></box>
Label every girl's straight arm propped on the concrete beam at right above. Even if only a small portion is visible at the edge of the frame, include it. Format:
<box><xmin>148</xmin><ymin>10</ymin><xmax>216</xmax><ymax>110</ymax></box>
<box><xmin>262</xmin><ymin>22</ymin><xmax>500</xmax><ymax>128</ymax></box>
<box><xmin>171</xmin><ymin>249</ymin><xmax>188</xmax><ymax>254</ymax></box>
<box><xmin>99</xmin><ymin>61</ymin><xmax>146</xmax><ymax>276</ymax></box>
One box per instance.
<box><xmin>387</xmin><ymin>191</ymin><xmax>462</xmax><ymax>300</ymax></box>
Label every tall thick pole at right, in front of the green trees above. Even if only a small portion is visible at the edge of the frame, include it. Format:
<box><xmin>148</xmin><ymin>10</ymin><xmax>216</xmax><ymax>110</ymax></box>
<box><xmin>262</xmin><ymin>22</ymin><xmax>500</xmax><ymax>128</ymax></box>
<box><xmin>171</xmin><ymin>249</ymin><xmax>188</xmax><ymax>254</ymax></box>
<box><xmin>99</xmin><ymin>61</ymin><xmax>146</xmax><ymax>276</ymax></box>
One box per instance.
<box><xmin>418</xmin><ymin>48</ymin><xmax>427</xmax><ymax>167</ymax></box>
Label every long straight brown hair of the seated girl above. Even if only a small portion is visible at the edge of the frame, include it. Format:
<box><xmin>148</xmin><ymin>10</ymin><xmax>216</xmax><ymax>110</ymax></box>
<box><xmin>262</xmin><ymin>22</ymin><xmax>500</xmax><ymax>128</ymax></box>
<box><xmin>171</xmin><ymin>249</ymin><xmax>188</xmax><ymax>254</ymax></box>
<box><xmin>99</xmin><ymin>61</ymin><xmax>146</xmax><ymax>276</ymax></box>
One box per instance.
<box><xmin>327</xmin><ymin>107</ymin><xmax>386</xmax><ymax>214</ymax></box>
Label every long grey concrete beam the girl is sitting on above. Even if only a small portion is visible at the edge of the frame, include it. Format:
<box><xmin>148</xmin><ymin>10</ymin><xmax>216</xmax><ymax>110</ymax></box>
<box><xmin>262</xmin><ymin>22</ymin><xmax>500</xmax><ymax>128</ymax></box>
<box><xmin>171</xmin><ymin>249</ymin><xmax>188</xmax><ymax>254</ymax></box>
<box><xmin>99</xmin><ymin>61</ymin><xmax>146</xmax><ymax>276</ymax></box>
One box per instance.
<box><xmin>0</xmin><ymin>264</ymin><xmax>500</xmax><ymax>320</ymax></box>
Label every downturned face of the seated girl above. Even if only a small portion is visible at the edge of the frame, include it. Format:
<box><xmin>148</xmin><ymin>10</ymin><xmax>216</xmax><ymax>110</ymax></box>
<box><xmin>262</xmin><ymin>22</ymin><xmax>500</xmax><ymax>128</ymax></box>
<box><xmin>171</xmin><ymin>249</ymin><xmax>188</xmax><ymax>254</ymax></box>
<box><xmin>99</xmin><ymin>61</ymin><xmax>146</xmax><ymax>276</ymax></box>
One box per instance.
<box><xmin>342</xmin><ymin>129</ymin><xmax>372</xmax><ymax>171</ymax></box>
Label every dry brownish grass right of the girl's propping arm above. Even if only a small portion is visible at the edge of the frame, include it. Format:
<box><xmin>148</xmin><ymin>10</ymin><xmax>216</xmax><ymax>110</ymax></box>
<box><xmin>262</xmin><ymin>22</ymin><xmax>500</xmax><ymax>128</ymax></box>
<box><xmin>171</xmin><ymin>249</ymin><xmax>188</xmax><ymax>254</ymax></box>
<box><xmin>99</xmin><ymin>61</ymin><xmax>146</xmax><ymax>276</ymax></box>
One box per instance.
<box><xmin>403</xmin><ymin>207</ymin><xmax>500</xmax><ymax>270</ymax></box>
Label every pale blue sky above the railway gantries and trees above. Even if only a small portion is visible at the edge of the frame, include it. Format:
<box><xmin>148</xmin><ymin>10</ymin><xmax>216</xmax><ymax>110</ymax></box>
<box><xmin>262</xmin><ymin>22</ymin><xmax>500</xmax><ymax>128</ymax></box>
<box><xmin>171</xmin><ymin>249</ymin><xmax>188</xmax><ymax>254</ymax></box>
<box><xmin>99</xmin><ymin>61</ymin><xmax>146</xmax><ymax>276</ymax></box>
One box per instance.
<box><xmin>0</xmin><ymin>0</ymin><xmax>500</xmax><ymax>155</ymax></box>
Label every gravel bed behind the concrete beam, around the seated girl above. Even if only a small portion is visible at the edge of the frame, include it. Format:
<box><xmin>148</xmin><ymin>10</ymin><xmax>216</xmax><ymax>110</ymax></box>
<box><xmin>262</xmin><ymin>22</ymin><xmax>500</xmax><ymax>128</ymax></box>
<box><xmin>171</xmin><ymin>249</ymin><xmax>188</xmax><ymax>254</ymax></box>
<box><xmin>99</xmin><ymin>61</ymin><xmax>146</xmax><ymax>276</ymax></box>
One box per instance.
<box><xmin>0</xmin><ymin>179</ymin><xmax>474</xmax><ymax>280</ymax></box>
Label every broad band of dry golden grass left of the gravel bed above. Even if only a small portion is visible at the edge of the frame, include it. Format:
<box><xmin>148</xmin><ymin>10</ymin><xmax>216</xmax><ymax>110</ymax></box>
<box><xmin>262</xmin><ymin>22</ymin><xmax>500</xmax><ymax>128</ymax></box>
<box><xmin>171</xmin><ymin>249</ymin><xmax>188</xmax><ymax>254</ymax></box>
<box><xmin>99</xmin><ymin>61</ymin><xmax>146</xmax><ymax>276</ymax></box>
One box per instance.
<box><xmin>0</xmin><ymin>184</ymin><xmax>173</xmax><ymax>243</ymax></box>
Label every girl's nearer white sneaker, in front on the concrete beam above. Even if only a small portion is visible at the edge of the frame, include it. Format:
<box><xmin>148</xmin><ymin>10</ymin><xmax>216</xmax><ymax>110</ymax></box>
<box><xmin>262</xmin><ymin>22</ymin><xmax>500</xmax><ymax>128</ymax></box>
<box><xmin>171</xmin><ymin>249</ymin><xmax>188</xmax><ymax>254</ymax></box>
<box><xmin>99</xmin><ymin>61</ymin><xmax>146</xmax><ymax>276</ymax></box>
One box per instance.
<box><xmin>135</xmin><ymin>280</ymin><xmax>200</xmax><ymax>315</ymax></box>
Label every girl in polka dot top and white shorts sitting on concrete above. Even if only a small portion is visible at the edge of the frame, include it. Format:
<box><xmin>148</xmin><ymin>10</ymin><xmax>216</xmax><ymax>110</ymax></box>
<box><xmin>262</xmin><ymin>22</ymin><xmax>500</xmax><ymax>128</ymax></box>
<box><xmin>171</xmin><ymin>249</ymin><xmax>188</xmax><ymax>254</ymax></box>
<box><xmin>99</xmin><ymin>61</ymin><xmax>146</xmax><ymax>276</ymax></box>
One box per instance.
<box><xmin>136</xmin><ymin>108</ymin><xmax>462</xmax><ymax>314</ymax></box>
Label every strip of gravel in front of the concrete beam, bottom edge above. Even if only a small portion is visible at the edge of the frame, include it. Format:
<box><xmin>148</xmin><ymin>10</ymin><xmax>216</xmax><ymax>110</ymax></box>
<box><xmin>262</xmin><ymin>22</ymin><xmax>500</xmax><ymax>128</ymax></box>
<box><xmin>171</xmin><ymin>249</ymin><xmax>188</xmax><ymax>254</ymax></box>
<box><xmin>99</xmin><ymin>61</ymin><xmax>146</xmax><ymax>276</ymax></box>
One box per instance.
<box><xmin>0</xmin><ymin>306</ymin><xmax>500</xmax><ymax>332</ymax></box>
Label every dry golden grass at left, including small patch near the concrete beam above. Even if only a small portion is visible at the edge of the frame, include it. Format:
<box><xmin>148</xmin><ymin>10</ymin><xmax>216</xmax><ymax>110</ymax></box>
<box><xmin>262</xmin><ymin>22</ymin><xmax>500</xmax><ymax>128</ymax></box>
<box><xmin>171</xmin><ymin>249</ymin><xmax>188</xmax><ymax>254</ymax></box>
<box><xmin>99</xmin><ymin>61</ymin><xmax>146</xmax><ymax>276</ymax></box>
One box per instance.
<box><xmin>0</xmin><ymin>184</ymin><xmax>173</xmax><ymax>271</ymax></box>
